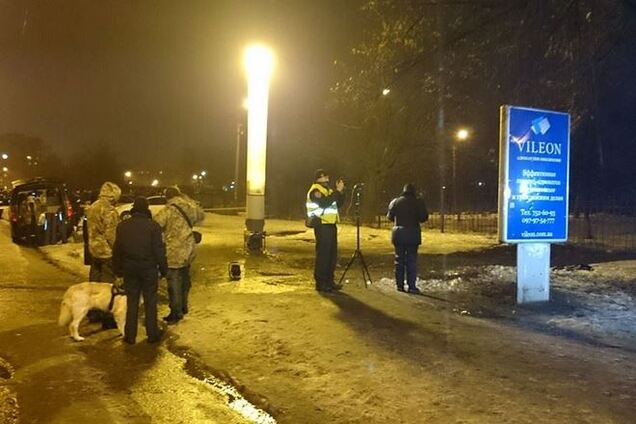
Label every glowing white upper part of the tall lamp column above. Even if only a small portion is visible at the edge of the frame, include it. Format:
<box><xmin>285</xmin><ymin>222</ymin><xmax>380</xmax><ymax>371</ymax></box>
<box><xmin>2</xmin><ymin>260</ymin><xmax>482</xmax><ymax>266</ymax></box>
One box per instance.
<box><xmin>244</xmin><ymin>44</ymin><xmax>274</xmax><ymax>195</ymax></box>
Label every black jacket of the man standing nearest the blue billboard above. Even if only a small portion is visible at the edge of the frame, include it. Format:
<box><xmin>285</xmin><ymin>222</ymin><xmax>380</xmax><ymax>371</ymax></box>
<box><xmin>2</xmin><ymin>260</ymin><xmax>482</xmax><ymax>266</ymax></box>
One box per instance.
<box><xmin>386</xmin><ymin>193</ymin><xmax>428</xmax><ymax>245</ymax></box>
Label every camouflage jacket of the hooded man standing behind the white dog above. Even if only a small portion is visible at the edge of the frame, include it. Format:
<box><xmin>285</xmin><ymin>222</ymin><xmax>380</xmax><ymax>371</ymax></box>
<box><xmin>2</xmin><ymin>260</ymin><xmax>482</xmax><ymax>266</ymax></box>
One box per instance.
<box><xmin>86</xmin><ymin>197</ymin><xmax>119</xmax><ymax>259</ymax></box>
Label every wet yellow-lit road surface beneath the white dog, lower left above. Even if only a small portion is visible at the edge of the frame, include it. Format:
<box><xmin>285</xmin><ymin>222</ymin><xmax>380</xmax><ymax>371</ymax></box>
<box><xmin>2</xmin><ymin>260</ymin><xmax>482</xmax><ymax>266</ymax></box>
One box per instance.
<box><xmin>0</xmin><ymin>222</ymin><xmax>250</xmax><ymax>423</ymax></box>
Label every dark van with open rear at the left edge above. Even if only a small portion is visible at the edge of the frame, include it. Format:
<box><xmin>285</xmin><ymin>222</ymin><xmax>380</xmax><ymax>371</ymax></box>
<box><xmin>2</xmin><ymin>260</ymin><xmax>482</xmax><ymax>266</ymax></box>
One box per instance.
<box><xmin>9</xmin><ymin>178</ymin><xmax>73</xmax><ymax>245</ymax></box>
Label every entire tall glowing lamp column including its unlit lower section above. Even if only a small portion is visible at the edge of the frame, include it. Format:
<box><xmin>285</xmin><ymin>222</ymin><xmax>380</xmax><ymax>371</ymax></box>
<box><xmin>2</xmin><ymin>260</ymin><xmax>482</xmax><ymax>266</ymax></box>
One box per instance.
<box><xmin>244</xmin><ymin>44</ymin><xmax>274</xmax><ymax>252</ymax></box>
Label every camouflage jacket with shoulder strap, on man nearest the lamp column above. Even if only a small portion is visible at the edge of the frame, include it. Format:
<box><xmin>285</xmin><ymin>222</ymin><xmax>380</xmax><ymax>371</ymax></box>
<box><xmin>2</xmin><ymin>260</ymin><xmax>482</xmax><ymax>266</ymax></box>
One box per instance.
<box><xmin>153</xmin><ymin>194</ymin><xmax>205</xmax><ymax>268</ymax></box>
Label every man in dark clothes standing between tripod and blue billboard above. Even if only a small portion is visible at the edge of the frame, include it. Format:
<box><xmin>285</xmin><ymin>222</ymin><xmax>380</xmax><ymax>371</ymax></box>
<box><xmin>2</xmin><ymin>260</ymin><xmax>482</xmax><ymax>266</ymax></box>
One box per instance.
<box><xmin>387</xmin><ymin>184</ymin><xmax>428</xmax><ymax>294</ymax></box>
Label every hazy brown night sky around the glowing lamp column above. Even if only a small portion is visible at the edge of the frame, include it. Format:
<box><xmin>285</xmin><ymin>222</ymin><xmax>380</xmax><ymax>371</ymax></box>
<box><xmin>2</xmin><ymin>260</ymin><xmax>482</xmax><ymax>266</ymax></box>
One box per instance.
<box><xmin>0</xmin><ymin>0</ymin><xmax>358</xmax><ymax>184</ymax></box>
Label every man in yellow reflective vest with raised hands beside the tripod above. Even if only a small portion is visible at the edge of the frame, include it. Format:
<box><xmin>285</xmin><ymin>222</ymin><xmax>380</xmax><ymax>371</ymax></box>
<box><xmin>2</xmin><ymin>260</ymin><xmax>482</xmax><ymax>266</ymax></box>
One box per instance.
<box><xmin>306</xmin><ymin>169</ymin><xmax>344</xmax><ymax>292</ymax></box>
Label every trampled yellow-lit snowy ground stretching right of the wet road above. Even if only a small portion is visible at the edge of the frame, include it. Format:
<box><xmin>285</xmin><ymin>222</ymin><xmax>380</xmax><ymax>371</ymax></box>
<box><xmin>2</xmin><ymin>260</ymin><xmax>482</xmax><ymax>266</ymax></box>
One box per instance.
<box><xmin>28</xmin><ymin>214</ymin><xmax>636</xmax><ymax>424</ymax></box>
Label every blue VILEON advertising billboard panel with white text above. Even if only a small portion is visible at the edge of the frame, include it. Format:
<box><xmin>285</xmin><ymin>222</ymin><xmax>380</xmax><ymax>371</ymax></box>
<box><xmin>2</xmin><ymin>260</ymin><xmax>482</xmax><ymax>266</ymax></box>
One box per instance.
<box><xmin>499</xmin><ymin>106</ymin><xmax>570</xmax><ymax>243</ymax></box>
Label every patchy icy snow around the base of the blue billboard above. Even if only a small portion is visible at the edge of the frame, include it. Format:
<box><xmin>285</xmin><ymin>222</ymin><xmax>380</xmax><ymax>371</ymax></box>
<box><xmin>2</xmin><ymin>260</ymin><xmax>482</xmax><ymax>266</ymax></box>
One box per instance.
<box><xmin>375</xmin><ymin>260</ymin><xmax>636</xmax><ymax>344</ymax></box>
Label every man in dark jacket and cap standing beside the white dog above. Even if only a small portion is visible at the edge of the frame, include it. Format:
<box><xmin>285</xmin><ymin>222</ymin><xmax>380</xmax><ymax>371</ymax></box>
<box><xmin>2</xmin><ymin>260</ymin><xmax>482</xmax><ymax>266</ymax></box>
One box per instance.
<box><xmin>113</xmin><ymin>197</ymin><xmax>168</xmax><ymax>344</ymax></box>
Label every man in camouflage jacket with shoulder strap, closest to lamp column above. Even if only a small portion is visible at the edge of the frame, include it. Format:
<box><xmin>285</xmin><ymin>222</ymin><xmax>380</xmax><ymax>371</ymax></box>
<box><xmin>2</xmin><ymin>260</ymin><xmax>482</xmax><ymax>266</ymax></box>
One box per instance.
<box><xmin>154</xmin><ymin>186</ymin><xmax>205</xmax><ymax>324</ymax></box>
